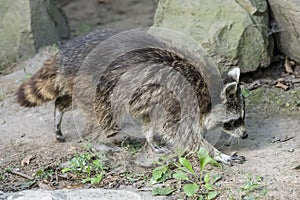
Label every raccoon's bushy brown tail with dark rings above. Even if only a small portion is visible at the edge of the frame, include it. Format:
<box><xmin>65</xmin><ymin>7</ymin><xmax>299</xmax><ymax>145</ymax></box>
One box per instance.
<box><xmin>16</xmin><ymin>56</ymin><xmax>58</xmax><ymax>107</ymax></box>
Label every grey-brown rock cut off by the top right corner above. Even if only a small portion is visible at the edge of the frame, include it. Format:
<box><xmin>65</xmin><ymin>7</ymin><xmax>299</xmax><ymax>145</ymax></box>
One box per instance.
<box><xmin>269</xmin><ymin>0</ymin><xmax>300</xmax><ymax>62</ymax></box>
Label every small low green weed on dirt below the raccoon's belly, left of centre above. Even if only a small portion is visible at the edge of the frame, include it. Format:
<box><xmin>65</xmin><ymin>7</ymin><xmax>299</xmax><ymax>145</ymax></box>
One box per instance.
<box><xmin>62</xmin><ymin>152</ymin><xmax>107</xmax><ymax>184</ymax></box>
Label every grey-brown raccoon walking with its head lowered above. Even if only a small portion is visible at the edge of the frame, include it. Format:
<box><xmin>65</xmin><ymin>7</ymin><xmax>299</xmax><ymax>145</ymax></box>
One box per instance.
<box><xmin>16</xmin><ymin>30</ymin><xmax>247</xmax><ymax>164</ymax></box>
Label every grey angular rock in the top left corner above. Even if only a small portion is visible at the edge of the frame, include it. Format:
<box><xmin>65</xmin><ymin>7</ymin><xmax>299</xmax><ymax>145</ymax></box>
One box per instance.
<box><xmin>0</xmin><ymin>0</ymin><xmax>70</xmax><ymax>69</ymax></box>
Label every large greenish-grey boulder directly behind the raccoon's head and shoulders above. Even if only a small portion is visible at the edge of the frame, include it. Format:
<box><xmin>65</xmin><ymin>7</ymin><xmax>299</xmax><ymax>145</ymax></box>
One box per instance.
<box><xmin>154</xmin><ymin>0</ymin><xmax>274</xmax><ymax>72</ymax></box>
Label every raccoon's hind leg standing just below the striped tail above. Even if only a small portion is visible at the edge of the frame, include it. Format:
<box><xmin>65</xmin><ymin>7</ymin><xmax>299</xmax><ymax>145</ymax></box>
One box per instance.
<box><xmin>54</xmin><ymin>95</ymin><xmax>72</xmax><ymax>142</ymax></box>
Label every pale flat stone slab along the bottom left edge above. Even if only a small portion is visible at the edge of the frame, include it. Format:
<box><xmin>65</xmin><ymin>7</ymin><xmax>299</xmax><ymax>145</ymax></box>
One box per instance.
<box><xmin>0</xmin><ymin>189</ymin><xmax>166</xmax><ymax>200</ymax></box>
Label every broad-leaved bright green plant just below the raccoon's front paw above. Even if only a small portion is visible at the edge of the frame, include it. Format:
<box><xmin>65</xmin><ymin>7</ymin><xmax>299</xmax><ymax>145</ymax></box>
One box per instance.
<box><xmin>150</xmin><ymin>148</ymin><xmax>221</xmax><ymax>199</ymax></box>
